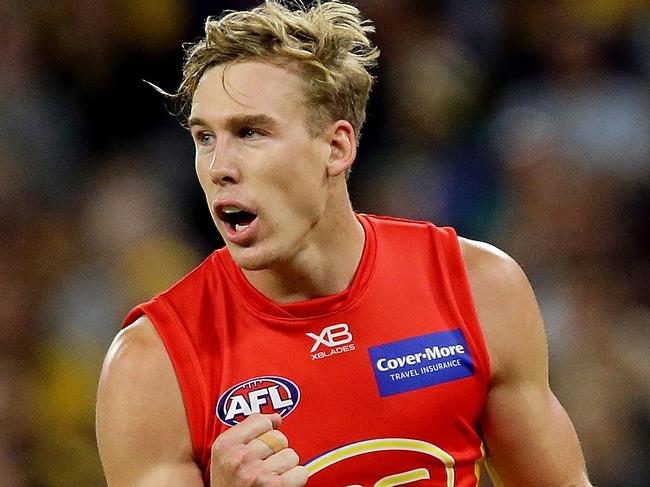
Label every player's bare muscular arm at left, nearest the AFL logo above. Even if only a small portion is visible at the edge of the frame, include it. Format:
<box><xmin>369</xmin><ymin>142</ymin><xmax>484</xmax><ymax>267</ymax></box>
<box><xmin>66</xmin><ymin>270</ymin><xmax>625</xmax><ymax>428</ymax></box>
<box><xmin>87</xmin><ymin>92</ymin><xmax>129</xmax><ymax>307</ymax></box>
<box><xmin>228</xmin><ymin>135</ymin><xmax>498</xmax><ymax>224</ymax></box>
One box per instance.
<box><xmin>97</xmin><ymin>318</ymin><xmax>203</xmax><ymax>487</ymax></box>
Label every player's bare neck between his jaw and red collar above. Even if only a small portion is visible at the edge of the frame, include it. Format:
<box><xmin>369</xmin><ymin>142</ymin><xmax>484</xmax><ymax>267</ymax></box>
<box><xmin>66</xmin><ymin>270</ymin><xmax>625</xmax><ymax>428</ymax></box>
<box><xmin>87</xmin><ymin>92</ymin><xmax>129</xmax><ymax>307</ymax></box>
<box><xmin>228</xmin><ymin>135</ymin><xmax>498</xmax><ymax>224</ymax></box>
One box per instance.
<box><xmin>243</xmin><ymin>207</ymin><xmax>365</xmax><ymax>303</ymax></box>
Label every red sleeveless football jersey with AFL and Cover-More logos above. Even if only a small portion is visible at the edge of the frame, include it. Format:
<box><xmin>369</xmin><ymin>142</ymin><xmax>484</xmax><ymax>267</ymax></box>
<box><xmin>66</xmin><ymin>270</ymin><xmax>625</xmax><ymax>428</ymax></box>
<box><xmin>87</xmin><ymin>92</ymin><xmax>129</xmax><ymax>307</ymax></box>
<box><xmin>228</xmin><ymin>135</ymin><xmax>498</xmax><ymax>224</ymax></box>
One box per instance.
<box><xmin>124</xmin><ymin>215</ymin><xmax>490</xmax><ymax>487</ymax></box>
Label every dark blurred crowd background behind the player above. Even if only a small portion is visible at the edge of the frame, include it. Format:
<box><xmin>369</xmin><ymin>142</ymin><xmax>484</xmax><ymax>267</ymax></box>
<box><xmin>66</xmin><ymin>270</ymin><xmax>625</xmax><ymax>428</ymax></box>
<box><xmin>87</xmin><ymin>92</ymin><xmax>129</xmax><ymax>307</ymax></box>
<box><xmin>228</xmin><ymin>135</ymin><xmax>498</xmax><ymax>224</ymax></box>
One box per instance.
<box><xmin>0</xmin><ymin>0</ymin><xmax>650</xmax><ymax>487</ymax></box>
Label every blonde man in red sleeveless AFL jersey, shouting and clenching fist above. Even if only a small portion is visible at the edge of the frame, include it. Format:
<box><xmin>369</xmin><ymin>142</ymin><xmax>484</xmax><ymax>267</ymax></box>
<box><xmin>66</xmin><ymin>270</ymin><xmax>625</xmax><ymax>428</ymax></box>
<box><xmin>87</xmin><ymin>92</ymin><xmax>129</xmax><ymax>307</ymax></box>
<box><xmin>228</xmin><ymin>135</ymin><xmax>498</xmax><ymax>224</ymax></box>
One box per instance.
<box><xmin>97</xmin><ymin>1</ymin><xmax>589</xmax><ymax>487</ymax></box>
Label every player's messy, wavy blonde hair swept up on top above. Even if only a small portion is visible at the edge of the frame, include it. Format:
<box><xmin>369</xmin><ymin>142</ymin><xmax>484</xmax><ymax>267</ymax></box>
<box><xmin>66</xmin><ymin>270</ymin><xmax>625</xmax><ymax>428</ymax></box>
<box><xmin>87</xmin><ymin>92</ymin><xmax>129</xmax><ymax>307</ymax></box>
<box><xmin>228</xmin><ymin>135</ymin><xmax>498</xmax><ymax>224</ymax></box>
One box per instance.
<box><xmin>171</xmin><ymin>0</ymin><xmax>379</xmax><ymax>140</ymax></box>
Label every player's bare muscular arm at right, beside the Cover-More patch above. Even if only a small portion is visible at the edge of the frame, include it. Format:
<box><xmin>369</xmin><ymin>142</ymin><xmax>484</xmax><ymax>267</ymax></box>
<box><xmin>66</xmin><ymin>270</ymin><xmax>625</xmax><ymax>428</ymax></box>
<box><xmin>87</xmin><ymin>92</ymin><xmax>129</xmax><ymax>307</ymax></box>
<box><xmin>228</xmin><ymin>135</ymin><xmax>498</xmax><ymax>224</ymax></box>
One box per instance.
<box><xmin>461</xmin><ymin>239</ymin><xmax>590</xmax><ymax>487</ymax></box>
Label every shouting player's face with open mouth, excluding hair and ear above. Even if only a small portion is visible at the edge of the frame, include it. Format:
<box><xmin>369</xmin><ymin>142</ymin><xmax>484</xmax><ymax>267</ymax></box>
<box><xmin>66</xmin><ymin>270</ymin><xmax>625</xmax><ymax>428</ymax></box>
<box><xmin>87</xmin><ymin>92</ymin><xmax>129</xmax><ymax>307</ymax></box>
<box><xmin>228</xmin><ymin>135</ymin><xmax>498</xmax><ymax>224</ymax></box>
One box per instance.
<box><xmin>189</xmin><ymin>61</ymin><xmax>330</xmax><ymax>270</ymax></box>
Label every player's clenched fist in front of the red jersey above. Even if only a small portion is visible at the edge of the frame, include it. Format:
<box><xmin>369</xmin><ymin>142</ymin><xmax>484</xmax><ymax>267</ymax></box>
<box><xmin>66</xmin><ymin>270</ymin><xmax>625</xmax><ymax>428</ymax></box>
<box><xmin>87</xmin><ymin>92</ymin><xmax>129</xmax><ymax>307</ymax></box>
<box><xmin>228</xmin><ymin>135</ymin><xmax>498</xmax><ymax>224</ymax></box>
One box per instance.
<box><xmin>210</xmin><ymin>414</ymin><xmax>308</xmax><ymax>487</ymax></box>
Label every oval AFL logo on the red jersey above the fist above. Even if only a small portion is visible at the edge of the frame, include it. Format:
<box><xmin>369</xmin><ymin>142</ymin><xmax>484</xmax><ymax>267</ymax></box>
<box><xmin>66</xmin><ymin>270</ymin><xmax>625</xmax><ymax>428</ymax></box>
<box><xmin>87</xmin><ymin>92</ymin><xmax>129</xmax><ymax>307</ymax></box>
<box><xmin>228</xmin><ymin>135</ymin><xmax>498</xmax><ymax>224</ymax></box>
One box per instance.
<box><xmin>217</xmin><ymin>376</ymin><xmax>300</xmax><ymax>426</ymax></box>
